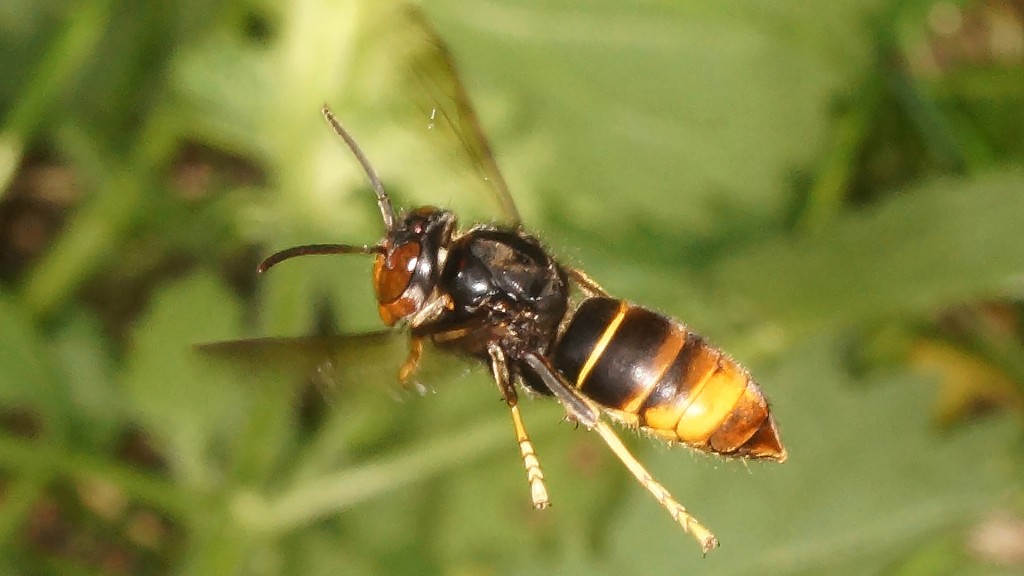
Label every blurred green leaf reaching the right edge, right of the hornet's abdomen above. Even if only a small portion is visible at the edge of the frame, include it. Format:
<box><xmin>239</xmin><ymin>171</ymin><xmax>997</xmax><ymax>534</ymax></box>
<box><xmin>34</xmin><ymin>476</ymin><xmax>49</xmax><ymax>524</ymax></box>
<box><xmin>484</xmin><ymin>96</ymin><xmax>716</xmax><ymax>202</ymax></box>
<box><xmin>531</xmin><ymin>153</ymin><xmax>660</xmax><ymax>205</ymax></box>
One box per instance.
<box><xmin>712</xmin><ymin>171</ymin><xmax>1024</xmax><ymax>329</ymax></box>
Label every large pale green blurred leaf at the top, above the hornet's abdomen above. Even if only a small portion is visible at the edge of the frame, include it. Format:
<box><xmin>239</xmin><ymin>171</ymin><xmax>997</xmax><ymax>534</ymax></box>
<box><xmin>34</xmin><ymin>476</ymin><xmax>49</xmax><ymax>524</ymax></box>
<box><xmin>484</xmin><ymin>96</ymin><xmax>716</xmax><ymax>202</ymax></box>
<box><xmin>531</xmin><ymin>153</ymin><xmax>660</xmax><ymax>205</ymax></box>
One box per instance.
<box><xmin>428</xmin><ymin>0</ymin><xmax>886</xmax><ymax>233</ymax></box>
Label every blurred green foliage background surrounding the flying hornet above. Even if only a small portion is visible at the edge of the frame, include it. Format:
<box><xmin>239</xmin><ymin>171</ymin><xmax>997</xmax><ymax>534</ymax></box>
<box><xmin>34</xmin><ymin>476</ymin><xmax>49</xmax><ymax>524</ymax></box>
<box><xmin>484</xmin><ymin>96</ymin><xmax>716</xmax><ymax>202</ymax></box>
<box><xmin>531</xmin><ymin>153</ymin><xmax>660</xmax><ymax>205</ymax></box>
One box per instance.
<box><xmin>0</xmin><ymin>0</ymin><xmax>1024</xmax><ymax>576</ymax></box>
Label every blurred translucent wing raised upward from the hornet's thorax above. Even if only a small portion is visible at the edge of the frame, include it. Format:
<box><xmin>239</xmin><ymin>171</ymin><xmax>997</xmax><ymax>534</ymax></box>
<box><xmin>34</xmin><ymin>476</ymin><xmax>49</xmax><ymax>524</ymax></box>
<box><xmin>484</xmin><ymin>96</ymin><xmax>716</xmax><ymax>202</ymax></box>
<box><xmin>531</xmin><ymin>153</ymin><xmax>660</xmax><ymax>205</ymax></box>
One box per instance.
<box><xmin>345</xmin><ymin>2</ymin><xmax>520</xmax><ymax>225</ymax></box>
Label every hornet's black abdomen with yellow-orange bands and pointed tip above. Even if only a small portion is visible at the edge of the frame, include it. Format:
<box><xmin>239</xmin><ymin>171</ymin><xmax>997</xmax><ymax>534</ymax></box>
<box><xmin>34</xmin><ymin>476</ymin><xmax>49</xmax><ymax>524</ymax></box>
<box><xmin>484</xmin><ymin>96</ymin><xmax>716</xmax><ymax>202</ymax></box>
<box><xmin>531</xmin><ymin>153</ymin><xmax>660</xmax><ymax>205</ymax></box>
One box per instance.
<box><xmin>552</xmin><ymin>297</ymin><xmax>785</xmax><ymax>461</ymax></box>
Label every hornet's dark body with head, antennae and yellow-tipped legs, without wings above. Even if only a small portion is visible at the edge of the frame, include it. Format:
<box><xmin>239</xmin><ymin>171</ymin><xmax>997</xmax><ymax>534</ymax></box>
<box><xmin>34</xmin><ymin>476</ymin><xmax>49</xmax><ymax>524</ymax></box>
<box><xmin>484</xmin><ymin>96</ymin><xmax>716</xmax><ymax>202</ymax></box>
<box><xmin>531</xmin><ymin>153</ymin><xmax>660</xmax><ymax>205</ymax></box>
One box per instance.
<box><xmin>251</xmin><ymin>106</ymin><xmax>786</xmax><ymax>553</ymax></box>
